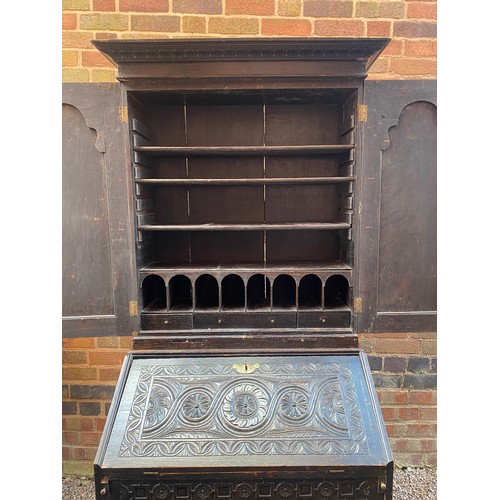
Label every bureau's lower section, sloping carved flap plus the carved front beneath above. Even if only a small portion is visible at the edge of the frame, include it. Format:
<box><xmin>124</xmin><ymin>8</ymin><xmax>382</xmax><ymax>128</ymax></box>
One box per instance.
<box><xmin>95</xmin><ymin>349</ymin><xmax>393</xmax><ymax>500</ymax></box>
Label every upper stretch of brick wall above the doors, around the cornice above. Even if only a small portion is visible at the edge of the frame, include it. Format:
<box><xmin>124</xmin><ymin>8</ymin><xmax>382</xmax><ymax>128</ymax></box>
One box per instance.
<box><xmin>62</xmin><ymin>0</ymin><xmax>437</xmax><ymax>82</ymax></box>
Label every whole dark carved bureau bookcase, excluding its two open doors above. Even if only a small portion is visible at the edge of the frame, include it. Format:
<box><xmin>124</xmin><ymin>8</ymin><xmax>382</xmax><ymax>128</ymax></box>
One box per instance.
<box><xmin>94</xmin><ymin>38</ymin><xmax>393</xmax><ymax>500</ymax></box>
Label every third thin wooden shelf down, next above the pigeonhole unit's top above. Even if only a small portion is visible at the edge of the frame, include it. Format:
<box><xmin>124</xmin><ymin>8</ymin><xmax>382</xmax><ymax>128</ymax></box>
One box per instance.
<box><xmin>137</xmin><ymin>222</ymin><xmax>351</xmax><ymax>231</ymax></box>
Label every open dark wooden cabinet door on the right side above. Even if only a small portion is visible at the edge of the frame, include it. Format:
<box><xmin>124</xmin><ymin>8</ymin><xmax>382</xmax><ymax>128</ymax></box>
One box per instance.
<box><xmin>356</xmin><ymin>81</ymin><xmax>437</xmax><ymax>333</ymax></box>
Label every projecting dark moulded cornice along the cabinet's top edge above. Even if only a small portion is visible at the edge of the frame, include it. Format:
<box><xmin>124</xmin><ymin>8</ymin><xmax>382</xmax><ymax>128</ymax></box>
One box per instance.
<box><xmin>92</xmin><ymin>38</ymin><xmax>390</xmax><ymax>78</ymax></box>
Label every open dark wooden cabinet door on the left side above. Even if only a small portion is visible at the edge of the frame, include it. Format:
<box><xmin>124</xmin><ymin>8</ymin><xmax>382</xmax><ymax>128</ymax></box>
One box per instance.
<box><xmin>62</xmin><ymin>84</ymin><xmax>137</xmax><ymax>337</ymax></box>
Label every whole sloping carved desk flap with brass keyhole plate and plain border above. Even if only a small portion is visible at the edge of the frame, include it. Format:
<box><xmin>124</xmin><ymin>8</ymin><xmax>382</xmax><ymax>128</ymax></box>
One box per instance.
<box><xmin>98</xmin><ymin>351</ymin><xmax>392</xmax><ymax>470</ymax></box>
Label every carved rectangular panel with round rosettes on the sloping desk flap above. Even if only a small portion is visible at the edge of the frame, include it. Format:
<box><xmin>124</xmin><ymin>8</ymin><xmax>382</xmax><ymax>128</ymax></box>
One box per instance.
<box><xmin>120</xmin><ymin>362</ymin><xmax>369</xmax><ymax>457</ymax></box>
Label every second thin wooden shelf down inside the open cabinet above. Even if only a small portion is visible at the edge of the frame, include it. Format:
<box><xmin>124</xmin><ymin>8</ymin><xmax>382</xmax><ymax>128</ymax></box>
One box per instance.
<box><xmin>135</xmin><ymin>177</ymin><xmax>354</xmax><ymax>186</ymax></box>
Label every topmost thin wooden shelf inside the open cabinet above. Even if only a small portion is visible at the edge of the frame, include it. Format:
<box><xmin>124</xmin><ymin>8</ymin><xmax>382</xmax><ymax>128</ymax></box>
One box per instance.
<box><xmin>134</xmin><ymin>144</ymin><xmax>354</xmax><ymax>156</ymax></box>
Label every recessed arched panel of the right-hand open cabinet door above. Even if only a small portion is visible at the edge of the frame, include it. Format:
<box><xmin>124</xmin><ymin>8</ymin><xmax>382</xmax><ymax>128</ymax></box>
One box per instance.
<box><xmin>378</xmin><ymin>101</ymin><xmax>437</xmax><ymax>316</ymax></box>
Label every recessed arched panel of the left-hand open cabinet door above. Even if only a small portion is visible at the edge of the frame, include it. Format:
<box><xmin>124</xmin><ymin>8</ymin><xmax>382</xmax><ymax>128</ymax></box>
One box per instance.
<box><xmin>62</xmin><ymin>105</ymin><xmax>114</xmax><ymax>317</ymax></box>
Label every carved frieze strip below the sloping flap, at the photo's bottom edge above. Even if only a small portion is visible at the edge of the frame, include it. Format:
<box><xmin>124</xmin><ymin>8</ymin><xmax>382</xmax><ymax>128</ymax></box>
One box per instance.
<box><xmin>110</xmin><ymin>478</ymin><xmax>380</xmax><ymax>500</ymax></box>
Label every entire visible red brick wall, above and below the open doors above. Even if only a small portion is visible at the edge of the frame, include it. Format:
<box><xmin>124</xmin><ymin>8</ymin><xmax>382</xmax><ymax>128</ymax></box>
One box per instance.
<box><xmin>62</xmin><ymin>0</ymin><xmax>437</xmax><ymax>474</ymax></box>
